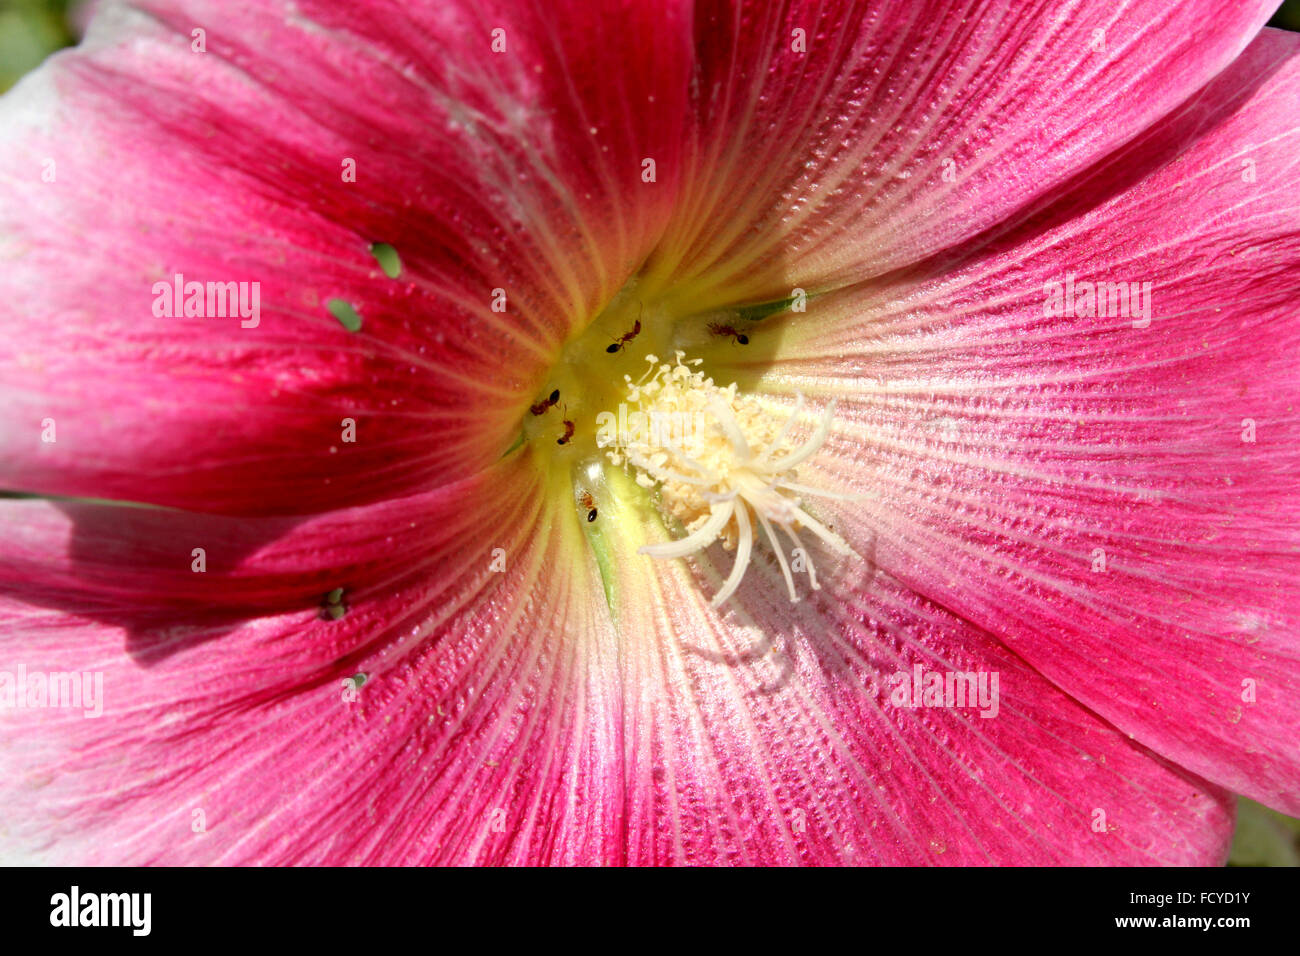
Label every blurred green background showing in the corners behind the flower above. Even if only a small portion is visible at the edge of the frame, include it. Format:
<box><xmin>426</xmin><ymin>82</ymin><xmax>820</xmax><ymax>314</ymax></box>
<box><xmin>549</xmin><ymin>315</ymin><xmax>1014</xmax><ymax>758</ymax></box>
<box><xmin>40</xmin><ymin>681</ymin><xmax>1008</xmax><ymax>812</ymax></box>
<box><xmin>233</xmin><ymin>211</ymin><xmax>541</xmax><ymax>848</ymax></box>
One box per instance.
<box><xmin>0</xmin><ymin>0</ymin><xmax>1300</xmax><ymax>866</ymax></box>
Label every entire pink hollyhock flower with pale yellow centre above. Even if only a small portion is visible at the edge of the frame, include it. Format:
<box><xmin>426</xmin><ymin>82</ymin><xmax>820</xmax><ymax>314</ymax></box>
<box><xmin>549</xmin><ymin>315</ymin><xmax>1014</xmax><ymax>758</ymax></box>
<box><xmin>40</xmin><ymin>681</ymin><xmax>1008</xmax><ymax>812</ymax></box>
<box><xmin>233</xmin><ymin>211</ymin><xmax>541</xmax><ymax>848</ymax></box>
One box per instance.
<box><xmin>0</xmin><ymin>0</ymin><xmax>1300</xmax><ymax>864</ymax></box>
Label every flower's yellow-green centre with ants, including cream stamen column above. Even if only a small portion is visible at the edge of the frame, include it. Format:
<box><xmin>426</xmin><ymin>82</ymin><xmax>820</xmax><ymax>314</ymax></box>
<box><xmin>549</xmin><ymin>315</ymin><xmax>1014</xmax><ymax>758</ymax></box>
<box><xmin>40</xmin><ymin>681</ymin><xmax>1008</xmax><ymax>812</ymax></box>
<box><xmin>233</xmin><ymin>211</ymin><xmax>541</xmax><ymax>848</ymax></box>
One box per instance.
<box><xmin>524</xmin><ymin>291</ymin><xmax>853</xmax><ymax>607</ymax></box>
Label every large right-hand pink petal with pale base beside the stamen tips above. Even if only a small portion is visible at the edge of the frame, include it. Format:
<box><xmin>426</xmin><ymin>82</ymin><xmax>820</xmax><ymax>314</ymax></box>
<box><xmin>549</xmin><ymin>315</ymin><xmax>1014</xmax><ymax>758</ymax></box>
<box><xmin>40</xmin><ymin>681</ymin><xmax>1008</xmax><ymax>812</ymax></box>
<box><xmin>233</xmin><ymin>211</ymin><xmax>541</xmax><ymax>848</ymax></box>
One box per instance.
<box><xmin>771</xmin><ymin>30</ymin><xmax>1300</xmax><ymax>814</ymax></box>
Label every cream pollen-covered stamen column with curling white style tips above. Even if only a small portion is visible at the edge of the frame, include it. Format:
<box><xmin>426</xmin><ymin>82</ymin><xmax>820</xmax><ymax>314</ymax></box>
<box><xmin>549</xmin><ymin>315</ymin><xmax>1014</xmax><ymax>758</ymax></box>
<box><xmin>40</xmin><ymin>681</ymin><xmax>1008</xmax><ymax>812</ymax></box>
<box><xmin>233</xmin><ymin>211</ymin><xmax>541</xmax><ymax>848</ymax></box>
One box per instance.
<box><xmin>607</xmin><ymin>352</ymin><xmax>853</xmax><ymax>607</ymax></box>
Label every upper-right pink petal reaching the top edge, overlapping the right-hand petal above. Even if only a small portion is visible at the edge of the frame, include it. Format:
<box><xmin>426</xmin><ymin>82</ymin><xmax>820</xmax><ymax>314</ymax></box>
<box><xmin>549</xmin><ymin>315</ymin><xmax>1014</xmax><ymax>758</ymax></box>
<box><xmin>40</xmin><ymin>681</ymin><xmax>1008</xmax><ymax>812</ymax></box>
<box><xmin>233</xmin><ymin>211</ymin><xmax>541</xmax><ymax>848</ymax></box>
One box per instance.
<box><xmin>650</xmin><ymin>0</ymin><xmax>1277</xmax><ymax>310</ymax></box>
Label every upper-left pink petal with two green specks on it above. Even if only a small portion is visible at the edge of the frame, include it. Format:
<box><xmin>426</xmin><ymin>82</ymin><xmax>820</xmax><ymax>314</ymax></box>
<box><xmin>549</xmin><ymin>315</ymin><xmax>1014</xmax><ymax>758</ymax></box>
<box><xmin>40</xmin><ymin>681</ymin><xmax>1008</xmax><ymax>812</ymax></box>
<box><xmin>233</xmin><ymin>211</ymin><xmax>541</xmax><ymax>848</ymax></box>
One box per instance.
<box><xmin>0</xmin><ymin>0</ymin><xmax>689</xmax><ymax>514</ymax></box>
